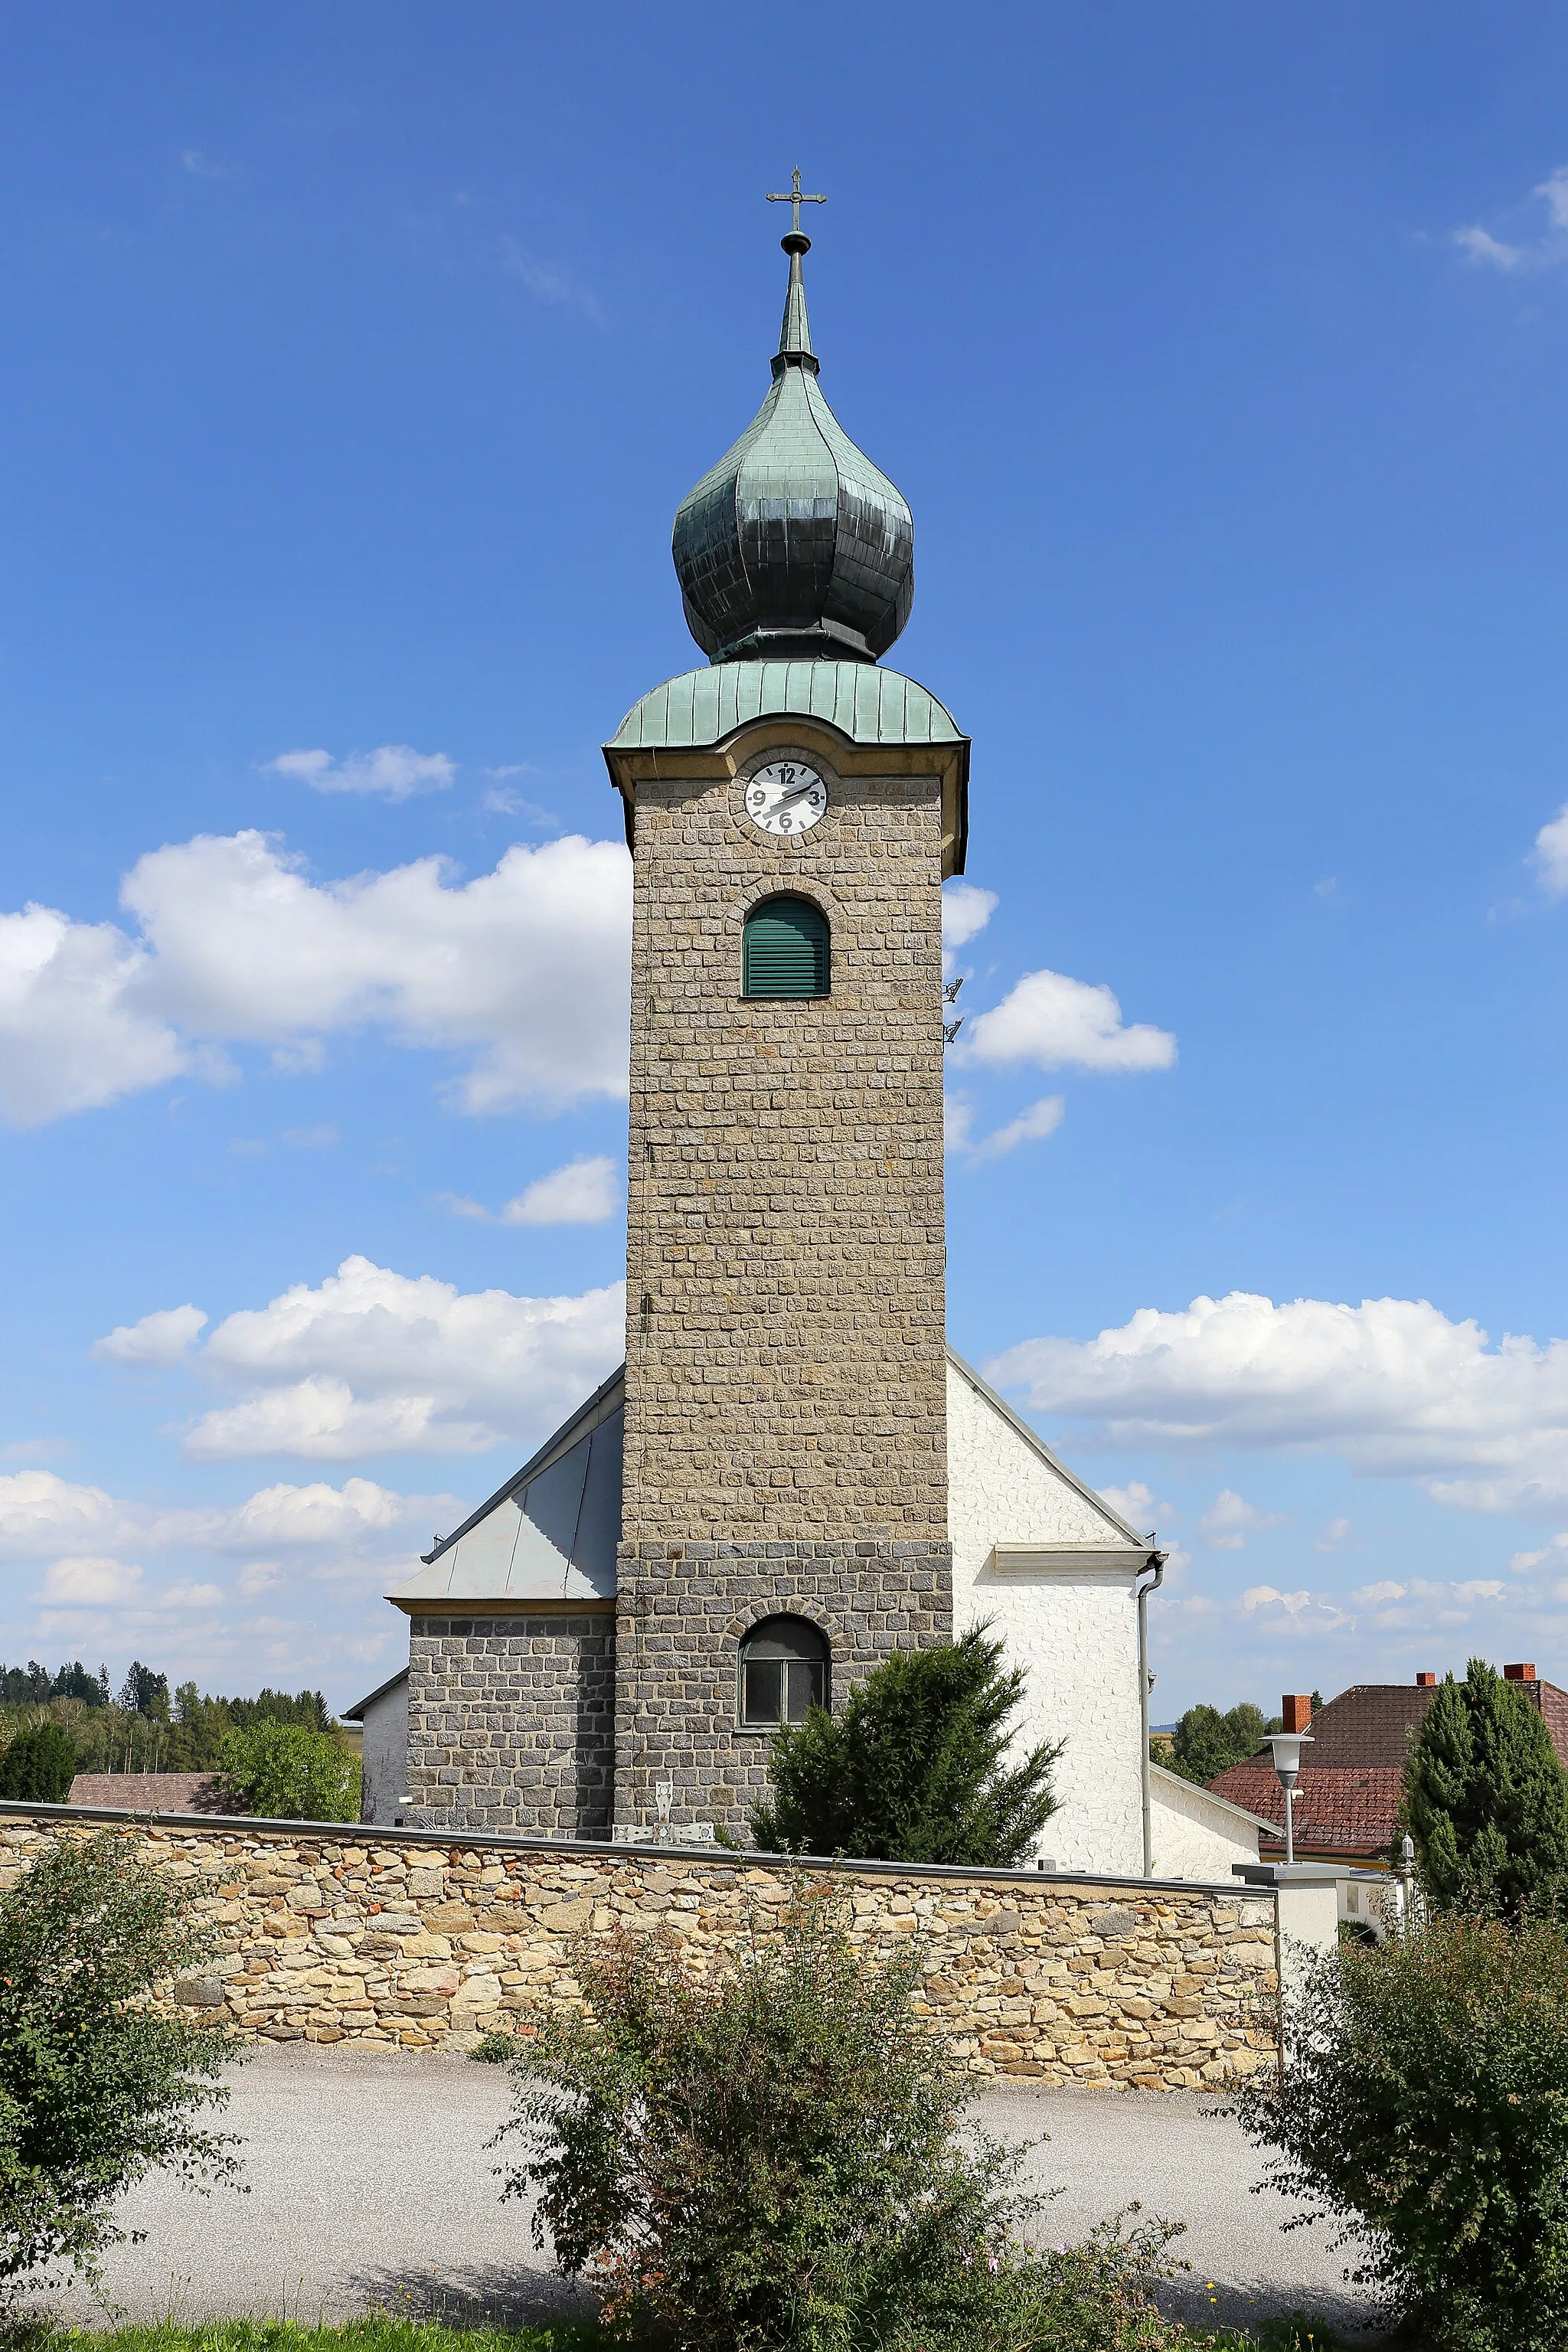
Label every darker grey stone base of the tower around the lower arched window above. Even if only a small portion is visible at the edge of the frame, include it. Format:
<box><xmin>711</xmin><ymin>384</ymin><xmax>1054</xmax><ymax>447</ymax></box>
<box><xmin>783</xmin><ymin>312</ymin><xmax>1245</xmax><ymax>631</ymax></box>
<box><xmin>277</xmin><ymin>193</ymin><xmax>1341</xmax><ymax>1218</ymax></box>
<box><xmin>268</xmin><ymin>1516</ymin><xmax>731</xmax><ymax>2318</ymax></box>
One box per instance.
<box><xmin>616</xmin><ymin>1540</ymin><xmax>952</xmax><ymax>1834</ymax></box>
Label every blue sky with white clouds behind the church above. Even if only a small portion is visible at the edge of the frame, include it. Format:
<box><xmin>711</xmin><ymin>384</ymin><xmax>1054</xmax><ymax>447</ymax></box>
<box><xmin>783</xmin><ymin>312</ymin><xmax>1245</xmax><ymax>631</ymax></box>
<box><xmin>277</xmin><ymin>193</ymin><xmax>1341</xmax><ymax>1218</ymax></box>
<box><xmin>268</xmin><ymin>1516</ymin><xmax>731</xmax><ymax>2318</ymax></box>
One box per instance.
<box><xmin>0</xmin><ymin>0</ymin><xmax>1568</xmax><ymax>1717</ymax></box>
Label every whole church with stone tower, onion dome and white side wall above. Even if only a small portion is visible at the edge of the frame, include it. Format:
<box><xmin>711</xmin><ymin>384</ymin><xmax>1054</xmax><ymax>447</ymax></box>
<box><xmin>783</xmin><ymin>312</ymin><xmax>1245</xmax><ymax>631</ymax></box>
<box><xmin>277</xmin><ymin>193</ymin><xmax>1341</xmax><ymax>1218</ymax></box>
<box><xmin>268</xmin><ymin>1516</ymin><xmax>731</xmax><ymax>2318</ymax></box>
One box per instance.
<box><xmin>371</xmin><ymin>209</ymin><xmax>1175</xmax><ymax>1872</ymax></box>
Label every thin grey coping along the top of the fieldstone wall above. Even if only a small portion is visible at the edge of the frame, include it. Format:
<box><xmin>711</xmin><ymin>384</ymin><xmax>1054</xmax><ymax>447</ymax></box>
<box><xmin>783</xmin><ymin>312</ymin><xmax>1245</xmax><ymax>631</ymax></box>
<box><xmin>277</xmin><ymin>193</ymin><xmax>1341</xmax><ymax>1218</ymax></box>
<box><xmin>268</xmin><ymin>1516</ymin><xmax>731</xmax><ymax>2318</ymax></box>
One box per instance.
<box><xmin>0</xmin><ymin>1797</ymin><xmax>1279</xmax><ymax>1909</ymax></box>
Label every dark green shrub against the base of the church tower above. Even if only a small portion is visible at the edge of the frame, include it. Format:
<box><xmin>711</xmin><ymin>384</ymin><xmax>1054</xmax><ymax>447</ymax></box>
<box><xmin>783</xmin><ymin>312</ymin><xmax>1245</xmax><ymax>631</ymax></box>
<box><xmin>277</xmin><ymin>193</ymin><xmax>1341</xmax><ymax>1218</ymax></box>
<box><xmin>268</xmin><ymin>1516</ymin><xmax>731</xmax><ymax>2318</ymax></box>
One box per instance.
<box><xmin>750</xmin><ymin>1625</ymin><xmax>1063</xmax><ymax>1870</ymax></box>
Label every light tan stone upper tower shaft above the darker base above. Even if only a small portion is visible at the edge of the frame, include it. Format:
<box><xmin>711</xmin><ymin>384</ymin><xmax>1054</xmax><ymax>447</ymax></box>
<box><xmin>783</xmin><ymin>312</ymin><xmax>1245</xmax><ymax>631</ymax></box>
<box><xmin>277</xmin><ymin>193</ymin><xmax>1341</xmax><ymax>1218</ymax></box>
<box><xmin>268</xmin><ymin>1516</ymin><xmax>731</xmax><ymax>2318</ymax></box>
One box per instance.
<box><xmin>621</xmin><ymin>717</ymin><xmax>947</xmax><ymax>1543</ymax></box>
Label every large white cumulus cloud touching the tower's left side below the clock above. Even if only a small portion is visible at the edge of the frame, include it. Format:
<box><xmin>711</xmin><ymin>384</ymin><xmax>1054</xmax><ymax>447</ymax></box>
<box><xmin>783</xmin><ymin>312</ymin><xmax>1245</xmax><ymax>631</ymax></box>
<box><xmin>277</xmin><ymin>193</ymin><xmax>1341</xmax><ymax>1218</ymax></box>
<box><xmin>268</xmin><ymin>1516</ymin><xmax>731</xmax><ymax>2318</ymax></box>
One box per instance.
<box><xmin>0</xmin><ymin>830</ymin><xmax>630</xmax><ymax>1126</ymax></box>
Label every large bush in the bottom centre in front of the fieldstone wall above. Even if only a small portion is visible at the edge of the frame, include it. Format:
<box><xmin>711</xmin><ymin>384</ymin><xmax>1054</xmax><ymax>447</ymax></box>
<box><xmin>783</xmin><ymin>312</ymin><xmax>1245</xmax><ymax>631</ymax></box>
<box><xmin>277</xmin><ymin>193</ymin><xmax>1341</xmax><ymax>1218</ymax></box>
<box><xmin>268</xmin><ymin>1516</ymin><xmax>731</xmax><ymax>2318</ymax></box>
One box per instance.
<box><xmin>496</xmin><ymin>1884</ymin><xmax>1178</xmax><ymax>2352</ymax></box>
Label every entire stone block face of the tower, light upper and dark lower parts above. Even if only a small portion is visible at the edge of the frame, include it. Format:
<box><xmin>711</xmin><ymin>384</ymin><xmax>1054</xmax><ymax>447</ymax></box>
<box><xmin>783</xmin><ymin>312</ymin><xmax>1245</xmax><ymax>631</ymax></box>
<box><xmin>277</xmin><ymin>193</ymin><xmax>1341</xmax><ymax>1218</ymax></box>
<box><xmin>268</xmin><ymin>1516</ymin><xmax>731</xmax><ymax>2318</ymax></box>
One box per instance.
<box><xmin>616</xmin><ymin>715</ymin><xmax>952</xmax><ymax>1828</ymax></box>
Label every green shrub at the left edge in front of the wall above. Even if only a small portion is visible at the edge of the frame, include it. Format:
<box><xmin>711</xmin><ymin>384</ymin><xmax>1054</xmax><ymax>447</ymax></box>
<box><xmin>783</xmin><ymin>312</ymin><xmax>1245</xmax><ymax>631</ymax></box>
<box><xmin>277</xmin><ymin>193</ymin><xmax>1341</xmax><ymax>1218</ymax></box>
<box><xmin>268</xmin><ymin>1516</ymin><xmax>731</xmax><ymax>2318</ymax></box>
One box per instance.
<box><xmin>0</xmin><ymin>1834</ymin><xmax>237</xmax><ymax>2279</ymax></box>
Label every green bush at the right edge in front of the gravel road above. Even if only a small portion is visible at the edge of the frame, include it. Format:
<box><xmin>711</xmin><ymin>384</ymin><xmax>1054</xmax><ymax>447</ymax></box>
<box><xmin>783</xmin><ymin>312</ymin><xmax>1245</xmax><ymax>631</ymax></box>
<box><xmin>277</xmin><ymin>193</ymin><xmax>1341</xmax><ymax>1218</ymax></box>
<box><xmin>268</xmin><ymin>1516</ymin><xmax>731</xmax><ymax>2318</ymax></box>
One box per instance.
<box><xmin>1236</xmin><ymin>1915</ymin><xmax>1568</xmax><ymax>2352</ymax></box>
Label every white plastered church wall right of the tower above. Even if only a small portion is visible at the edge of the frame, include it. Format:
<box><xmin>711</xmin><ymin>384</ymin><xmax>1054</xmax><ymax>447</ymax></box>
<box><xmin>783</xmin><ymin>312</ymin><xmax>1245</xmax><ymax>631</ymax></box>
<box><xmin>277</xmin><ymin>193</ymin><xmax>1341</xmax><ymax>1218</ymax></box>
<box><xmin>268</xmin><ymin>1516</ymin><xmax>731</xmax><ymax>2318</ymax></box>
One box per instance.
<box><xmin>947</xmin><ymin>1357</ymin><xmax>1142</xmax><ymax>1877</ymax></box>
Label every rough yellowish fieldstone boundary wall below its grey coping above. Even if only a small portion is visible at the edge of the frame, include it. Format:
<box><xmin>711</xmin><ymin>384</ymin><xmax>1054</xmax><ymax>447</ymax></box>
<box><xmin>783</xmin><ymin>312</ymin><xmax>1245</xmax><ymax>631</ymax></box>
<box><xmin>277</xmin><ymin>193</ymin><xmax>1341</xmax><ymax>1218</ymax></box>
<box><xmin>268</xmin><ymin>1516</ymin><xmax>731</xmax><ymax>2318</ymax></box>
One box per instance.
<box><xmin>0</xmin><ymin>1806</ymin><xmax>1276</xmax><ymax>2091</ymax></box>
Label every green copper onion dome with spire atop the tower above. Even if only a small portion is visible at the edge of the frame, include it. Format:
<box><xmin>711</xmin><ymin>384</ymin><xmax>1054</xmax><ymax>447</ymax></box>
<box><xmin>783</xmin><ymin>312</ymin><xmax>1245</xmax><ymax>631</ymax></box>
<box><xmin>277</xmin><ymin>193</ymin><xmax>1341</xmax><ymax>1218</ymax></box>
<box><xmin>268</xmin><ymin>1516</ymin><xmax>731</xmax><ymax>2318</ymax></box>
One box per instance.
<box><xmin>672</xmin><ymin>230</ymin><xmax>914</xmax><ymax>661</ymax></box>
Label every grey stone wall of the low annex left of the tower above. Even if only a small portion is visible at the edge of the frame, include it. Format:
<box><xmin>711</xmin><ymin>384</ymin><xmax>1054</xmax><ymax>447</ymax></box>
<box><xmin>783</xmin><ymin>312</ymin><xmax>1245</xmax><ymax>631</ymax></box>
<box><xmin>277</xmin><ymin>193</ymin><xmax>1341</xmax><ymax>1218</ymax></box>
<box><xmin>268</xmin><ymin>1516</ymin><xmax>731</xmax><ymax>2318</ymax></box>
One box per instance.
<box><xmin>404</xmin><ymin>1609</ymin><xmax>616</xmax><ymax>1837</ymax></box>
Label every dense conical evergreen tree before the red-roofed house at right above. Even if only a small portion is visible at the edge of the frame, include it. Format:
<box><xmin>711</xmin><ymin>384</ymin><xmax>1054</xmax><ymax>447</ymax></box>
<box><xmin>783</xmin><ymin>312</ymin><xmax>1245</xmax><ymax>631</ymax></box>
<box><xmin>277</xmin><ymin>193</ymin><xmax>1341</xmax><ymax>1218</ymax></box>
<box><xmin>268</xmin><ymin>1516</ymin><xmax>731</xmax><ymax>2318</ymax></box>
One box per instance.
<box><xmin>1406</xmin><ymin>1658</ymin><xmax>1568</xmax><ymax>1915</ymax></box>
